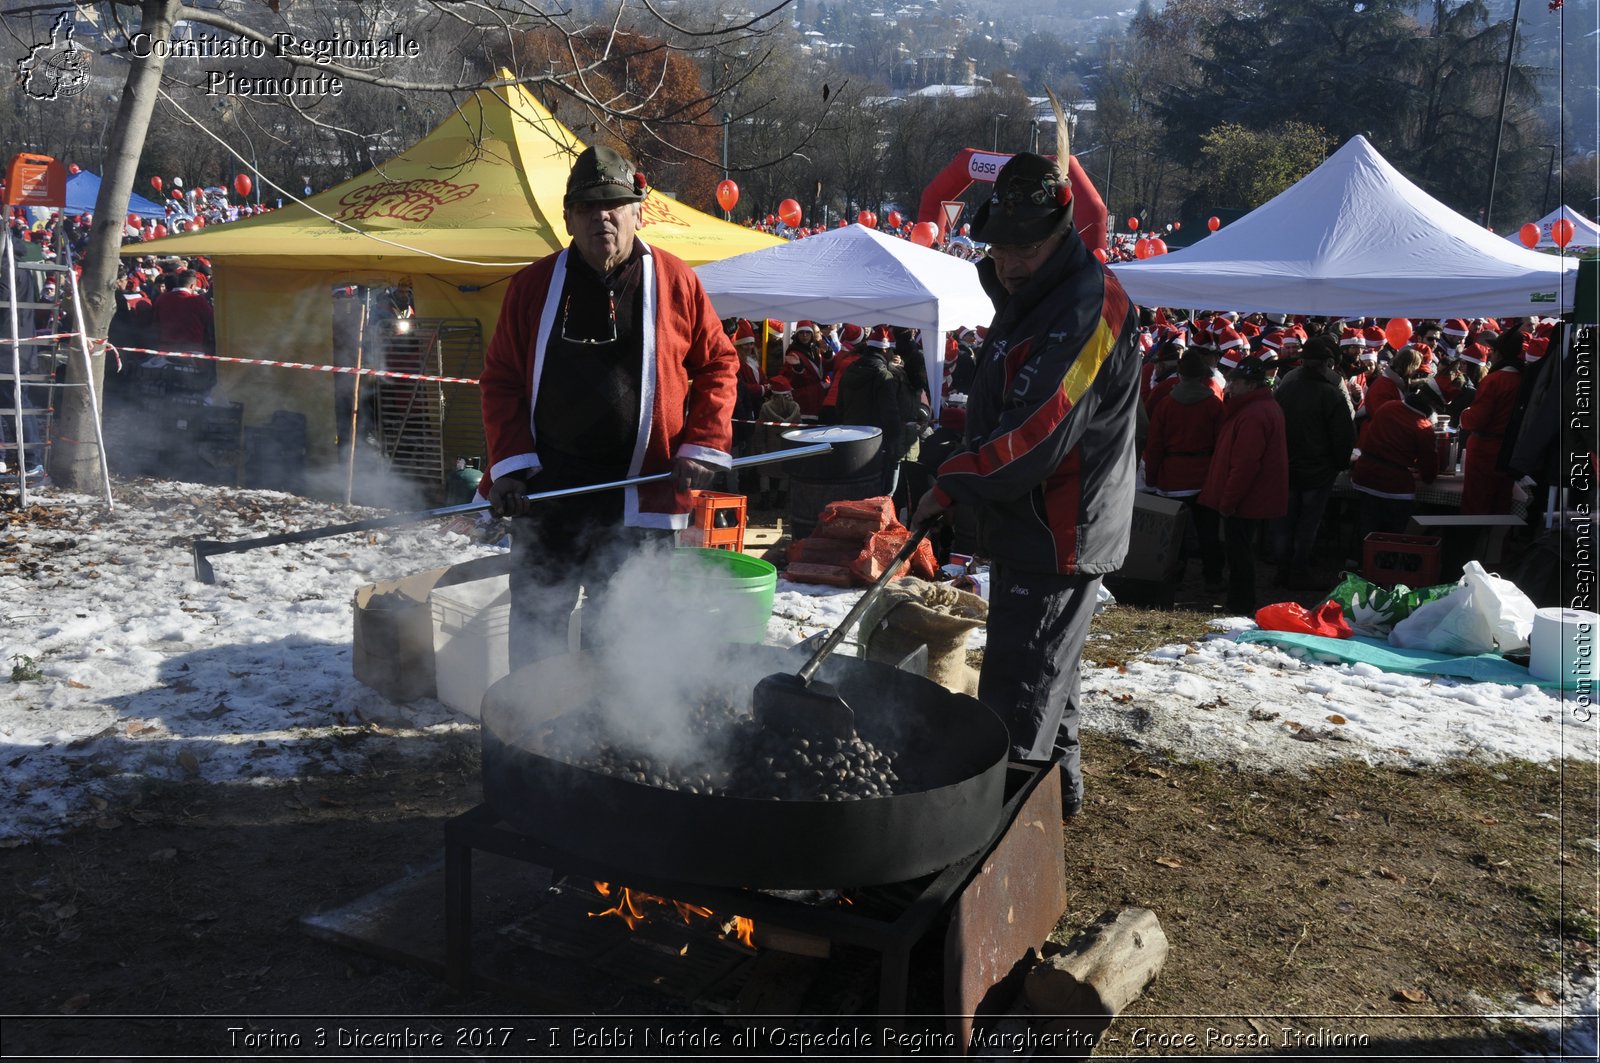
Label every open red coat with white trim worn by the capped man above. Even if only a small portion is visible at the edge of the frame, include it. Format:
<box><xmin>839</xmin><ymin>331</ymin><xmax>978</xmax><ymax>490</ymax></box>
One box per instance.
<box><xmin>478</xmin><ymin>240</ymin><xmax>739</xmax><ymax>528</ymax></box>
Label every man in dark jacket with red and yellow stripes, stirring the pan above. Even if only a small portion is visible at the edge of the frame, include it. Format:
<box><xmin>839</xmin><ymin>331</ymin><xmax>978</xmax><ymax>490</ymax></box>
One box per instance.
<box><xmin>912</xmin><ymin>152</ymin><xmax>1139</xmax><ymax>816</ymax></box>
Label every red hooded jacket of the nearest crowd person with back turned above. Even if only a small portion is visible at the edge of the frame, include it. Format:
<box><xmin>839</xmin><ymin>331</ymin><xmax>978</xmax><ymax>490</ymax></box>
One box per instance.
<box><xmin>1200</xmin><ymin>387</ymin><xmax>1290</xmax><ymax>520</ymax></box>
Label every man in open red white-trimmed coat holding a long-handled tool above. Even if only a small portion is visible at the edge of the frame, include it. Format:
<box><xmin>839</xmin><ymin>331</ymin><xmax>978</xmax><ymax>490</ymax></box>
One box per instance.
<box><xmin>480</xmin><ymin>140</ymin><xmax>739</xmax><ymax>660</ymax></box>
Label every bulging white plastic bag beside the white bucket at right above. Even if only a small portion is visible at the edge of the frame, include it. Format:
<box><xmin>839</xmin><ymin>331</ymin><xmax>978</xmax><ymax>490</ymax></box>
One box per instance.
<box><xmin>1389</xmin><ymin>560</ymin><xmax>1536</xmax><ymax>656</ymax></box>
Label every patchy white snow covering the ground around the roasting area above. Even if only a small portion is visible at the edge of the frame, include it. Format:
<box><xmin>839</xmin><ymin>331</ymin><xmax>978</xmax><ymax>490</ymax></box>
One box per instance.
<box><xmin>0</xmin><ymin>483</ymin><xmax>1600</xmax><ymax>1052</ymax></box>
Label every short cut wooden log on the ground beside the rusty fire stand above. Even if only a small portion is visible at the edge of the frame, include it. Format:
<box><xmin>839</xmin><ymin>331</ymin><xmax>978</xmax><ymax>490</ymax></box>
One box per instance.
<box><xmin>1022</xmin><ymin>908</ymin><xmax>1166</xmax><ymax>1045</ymax></box>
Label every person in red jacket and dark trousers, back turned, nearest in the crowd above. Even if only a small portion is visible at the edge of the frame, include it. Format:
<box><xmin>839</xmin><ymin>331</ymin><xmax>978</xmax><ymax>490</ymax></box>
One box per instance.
<box><xmin>1200</xmin><ymin>355</ymin><xmax>1290</xmax><ymax>616</ymax></box>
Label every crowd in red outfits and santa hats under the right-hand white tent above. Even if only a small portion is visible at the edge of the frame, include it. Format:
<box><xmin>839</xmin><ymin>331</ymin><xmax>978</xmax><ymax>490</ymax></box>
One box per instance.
<box><xmin>1139</xmin><ymin>309</ymin><xmax>1557</xmax><ymax>615</ymax></box>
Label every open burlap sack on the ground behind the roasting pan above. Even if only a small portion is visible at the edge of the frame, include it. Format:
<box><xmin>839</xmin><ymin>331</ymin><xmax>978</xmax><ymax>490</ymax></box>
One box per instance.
<box><xmin>856</xmin><ymin>576</ymin><xmax>989</xmax><ymax>695</ymax></box>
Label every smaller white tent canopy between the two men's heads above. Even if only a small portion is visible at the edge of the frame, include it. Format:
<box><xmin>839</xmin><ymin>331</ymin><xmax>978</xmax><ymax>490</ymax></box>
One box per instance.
<box><xmin>694</xmin><ymin>226</ymin><xmax>994</xmax><ymax>411</ymax></box>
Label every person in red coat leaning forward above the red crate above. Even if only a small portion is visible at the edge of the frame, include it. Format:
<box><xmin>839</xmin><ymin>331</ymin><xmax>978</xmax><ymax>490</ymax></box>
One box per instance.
<box><xmin>1350</xmin><ymin>379</ymin><xmax>1445</xmax><ymax>543</ymax></box>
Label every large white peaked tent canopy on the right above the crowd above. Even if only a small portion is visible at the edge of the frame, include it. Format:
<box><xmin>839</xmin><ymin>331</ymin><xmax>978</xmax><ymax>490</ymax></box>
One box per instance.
<box><xmin>1112</xmin><ymin>136</ymin><xmax>1578</xmax><ymax>317</ymax></box>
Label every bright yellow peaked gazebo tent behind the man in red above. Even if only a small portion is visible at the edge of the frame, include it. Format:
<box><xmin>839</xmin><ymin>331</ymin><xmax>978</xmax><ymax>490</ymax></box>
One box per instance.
<box><xmin>134</xmin><ymin>76</ymin><xmax>782</xmax><ymax>470</ymax></box>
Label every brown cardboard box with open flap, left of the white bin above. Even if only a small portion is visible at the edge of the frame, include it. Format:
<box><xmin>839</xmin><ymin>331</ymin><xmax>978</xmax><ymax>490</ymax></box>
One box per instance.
<box><xmin>350</xmin><ymin>554</ymin><xmax>510</xmax><ymax>701</ymax></box>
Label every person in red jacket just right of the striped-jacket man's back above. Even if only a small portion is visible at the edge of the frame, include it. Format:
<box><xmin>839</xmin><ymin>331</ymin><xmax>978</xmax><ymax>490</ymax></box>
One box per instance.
<box><xmin>1144</xmin><ymin>347</ymin><xmax>1222</xmax><ymax>591</ymax></box>
